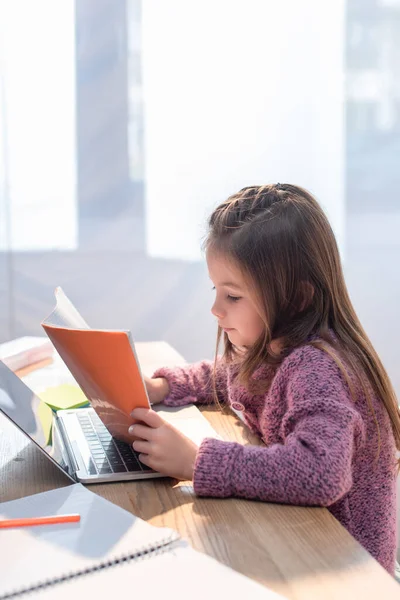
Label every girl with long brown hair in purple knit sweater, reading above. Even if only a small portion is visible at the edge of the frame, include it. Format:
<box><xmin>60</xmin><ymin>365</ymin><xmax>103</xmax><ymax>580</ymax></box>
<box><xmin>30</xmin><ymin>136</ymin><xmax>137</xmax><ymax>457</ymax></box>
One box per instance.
<box><xmin>130</xmin><ymin>184</ymin><xmax>400</xmax><ymax>574</ymax></box>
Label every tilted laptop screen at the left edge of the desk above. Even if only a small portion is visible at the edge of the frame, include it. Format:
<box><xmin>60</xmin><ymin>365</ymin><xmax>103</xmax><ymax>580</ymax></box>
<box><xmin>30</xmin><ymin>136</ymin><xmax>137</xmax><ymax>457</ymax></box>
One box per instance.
<box><xmin>0</xmin><ymin>361</ymin><xmax>74</xmax><ymax>474</ymax></box>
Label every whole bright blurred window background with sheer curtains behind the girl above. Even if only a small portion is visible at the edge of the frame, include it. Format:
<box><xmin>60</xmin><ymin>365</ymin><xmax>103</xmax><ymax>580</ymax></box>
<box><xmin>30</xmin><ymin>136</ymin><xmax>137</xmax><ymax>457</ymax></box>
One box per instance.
<box><xmin>0</xmin><ymin>0</ymin><xmax>400</xmax><ymax>394</ymax></box>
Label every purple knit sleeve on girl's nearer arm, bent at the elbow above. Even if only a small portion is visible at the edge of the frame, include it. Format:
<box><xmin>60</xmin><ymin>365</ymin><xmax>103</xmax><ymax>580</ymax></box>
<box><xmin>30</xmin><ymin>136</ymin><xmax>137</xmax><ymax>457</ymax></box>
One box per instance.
<box><xmin>194</xmin><ymin>349</ymin><xmax>363</xmax><ymax>506</ymax></box>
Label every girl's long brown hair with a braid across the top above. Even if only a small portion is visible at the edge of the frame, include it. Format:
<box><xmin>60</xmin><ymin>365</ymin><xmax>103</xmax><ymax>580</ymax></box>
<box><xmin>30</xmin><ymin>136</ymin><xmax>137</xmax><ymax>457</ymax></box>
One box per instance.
<box><xmin>205</xmin><ymin>184</ymin><xmax>400</xmax><ymax>449</ymax></box>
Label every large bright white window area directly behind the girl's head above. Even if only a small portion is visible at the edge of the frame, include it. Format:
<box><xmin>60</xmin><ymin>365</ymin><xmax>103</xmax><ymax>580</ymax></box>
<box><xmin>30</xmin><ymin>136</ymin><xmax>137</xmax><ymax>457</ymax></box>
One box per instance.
<box><xmin>142</xmin><ymin>0</ymin><xmax>345</xmax><ymax>259</ymax></box>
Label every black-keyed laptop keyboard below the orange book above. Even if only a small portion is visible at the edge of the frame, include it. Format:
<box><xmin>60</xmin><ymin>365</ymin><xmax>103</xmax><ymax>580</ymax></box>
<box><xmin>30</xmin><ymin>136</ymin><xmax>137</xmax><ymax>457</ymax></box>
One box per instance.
<box><xmin>77</xmin><ymin>411</ymin><xmax>152</xmax><ymax>475</ymax></box>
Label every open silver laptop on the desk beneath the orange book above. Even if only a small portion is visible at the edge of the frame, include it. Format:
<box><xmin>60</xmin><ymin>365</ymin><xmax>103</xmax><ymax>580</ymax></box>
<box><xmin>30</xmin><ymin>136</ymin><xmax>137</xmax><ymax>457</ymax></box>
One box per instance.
<box><xmin>0</xmin><ymin>361</ymin><xmax>218</xmax><ymax>484</ymax></box>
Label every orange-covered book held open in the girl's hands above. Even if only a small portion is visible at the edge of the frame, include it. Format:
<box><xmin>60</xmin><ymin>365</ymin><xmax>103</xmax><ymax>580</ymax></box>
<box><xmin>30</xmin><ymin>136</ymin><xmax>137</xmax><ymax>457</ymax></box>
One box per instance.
<box><xmin>42</xmin><ymin>287</ymin><xmax>150</xmax><ymax>443</ymax></box>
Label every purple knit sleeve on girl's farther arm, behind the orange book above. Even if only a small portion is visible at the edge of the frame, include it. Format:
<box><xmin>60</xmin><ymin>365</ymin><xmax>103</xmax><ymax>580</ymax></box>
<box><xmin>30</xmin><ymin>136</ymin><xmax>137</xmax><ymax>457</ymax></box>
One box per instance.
<box><xmin>153</xmin><ymin>359</ymin><xmax>228</xmax><ymax>406</ymax></box>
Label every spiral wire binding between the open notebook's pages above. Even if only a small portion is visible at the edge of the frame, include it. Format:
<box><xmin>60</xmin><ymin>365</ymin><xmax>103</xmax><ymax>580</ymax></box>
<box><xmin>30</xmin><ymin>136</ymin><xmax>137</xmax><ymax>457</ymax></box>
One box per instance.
<box><xmin>0</xmin><ymin>532</ymin><xmax>181</xmax><ymax>600</ymax></box>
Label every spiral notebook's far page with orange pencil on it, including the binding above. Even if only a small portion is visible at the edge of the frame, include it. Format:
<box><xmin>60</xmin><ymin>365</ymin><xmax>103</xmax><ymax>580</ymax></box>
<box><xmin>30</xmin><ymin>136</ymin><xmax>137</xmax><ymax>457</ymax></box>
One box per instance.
<box><xmin>0</xmin><ymin>484</ymin><xmax>179</xmax><ymax>600</ymax></box>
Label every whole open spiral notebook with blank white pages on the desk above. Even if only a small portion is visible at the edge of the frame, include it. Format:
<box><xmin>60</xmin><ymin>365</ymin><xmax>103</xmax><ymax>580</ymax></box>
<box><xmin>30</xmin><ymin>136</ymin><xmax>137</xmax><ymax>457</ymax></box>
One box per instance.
<box><xmin>0</xmin><ymin>484</ymin><xmax>284</xmax><ymax>600</ymax></box>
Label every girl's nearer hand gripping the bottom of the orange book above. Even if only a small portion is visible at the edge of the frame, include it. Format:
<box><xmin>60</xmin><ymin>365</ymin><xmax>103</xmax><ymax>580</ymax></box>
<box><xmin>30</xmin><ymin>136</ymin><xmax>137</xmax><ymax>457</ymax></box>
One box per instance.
<box><xmin>129</xmin><ymin>408</ymin><xmax>198</xmax><ymax>480</ymax></box>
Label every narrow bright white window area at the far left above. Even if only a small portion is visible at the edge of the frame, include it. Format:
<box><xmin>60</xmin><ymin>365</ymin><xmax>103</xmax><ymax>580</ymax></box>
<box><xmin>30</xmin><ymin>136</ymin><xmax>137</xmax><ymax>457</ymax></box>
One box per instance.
<box><xmin>0</xmin><ymin>0</ymin><xmax>77</xmax><ymax>250</ymax></box>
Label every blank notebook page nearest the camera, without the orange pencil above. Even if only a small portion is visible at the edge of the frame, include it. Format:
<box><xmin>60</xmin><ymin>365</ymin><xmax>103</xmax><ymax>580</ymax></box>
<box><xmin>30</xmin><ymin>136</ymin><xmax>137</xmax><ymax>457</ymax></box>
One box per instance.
<box><xmin>27</xmin><ymin>542</ymin><xmax>287</xmax><ymax>600</ymax></box>
